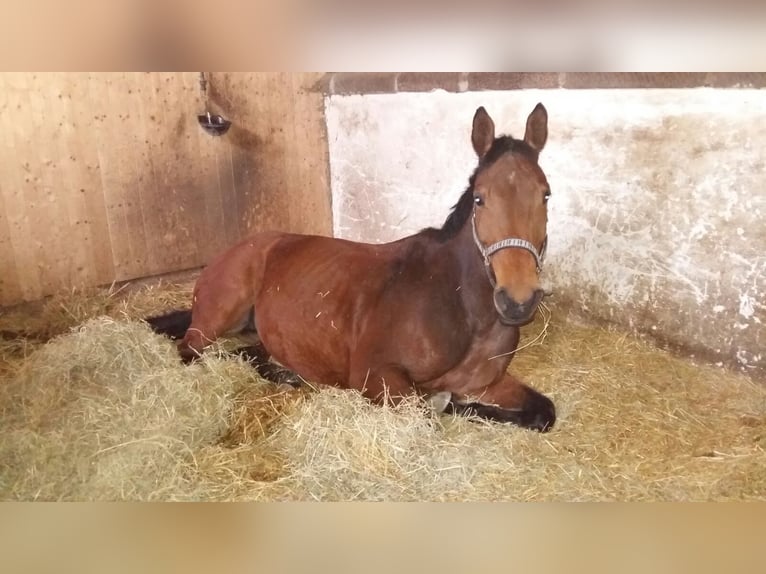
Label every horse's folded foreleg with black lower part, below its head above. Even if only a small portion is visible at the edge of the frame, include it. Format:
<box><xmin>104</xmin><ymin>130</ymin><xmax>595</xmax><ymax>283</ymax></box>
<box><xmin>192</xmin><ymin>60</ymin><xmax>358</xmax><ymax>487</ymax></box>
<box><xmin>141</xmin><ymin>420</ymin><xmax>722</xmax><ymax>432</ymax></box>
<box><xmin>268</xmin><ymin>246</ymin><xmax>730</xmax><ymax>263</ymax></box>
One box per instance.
<box><xmin>444</xmin><ymin>375</ymin><xmax>556</xmax><ymax>432</ymax></box>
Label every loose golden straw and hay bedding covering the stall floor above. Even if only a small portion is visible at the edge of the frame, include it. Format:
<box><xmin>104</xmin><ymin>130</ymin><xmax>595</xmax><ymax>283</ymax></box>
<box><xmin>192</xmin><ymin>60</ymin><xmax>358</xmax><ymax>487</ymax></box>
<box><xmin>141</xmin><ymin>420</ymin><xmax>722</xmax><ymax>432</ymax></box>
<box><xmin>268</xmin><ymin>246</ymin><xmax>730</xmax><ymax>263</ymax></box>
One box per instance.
<box><xmin>0</xmin><ymin>285</ymin><xmax>766</xmax><ymax>500</ymax></box>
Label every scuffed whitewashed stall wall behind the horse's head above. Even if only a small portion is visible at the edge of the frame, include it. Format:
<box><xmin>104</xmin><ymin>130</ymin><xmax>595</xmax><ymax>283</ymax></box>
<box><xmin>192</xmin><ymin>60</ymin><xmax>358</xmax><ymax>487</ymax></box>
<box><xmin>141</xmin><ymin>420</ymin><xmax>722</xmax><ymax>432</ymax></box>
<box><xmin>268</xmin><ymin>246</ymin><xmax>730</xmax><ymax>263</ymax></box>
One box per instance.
<box><xmin>325</xmin><ymin>88</ymin><xmax>766</xmax><ymax>374</ymax></box>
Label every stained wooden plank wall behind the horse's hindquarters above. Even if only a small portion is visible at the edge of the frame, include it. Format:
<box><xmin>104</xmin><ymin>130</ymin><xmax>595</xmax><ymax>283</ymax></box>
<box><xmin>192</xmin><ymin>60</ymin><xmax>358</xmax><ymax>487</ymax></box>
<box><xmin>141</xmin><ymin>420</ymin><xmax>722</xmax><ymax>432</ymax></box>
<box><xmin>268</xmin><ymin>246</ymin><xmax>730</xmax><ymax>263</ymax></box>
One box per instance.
<box><xmin>0</xmin><ymin>72</ymin><xmax>332</xmax><ymax>305</ymax></box>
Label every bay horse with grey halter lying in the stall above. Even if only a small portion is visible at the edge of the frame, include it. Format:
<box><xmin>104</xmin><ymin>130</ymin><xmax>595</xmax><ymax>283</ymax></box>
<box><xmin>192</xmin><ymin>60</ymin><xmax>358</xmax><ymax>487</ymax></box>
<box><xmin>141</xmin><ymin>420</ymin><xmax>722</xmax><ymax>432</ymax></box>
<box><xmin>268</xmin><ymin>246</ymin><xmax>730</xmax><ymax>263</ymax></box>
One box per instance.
<box><xmin>147</xmin><ymin>104</ymin><xmax>556</xmax><ymax>432</ymax></box>
